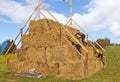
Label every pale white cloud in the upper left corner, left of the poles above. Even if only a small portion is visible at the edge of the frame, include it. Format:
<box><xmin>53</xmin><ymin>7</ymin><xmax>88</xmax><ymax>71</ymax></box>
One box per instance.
<box><xmin>0</xmin><ymin>0</ymin><xmax>33</xmax><ymax>23</ymax></box>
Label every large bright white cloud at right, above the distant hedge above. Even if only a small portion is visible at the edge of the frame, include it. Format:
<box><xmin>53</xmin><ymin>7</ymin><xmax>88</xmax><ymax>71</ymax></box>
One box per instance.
<box><xmin>73</xmin><ymin>0</ymin><xmax>120</xmax><ymax>37</ymax></box>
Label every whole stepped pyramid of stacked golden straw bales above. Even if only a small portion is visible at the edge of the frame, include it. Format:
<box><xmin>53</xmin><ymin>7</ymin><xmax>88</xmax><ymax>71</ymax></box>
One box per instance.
<box><xmin>9</xmin><ymin>19</ymin><xmax>102</xmax><ymax>79</ymax></box>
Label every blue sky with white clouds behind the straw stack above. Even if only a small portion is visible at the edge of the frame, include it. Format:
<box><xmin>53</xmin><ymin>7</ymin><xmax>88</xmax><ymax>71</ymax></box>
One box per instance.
<box><xmin>0</xmin><ymin>0</ymin><xmax>120</xmax><ymax>43</ymax></box>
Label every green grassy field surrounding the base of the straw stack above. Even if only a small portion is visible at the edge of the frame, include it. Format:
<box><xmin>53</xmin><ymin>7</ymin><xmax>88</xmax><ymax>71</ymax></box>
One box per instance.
<box><xmin>0</xmin><ymin>46</ymin><xmax>120</xmax><ymax>82</ymax></box>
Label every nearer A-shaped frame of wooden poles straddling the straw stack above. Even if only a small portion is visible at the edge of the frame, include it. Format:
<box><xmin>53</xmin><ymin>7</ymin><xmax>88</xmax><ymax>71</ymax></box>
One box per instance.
<box><xmin>5</xmin><ymin>0</ymin><xmax>88</xmax><ymax>66</ymax></box>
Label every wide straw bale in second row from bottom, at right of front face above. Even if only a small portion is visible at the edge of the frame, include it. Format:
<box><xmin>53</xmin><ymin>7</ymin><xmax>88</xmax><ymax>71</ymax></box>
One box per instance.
<box><xmin>46</xmin><ymin>45</ymin><xmax>79</xmax><ymax>64</ymax></box>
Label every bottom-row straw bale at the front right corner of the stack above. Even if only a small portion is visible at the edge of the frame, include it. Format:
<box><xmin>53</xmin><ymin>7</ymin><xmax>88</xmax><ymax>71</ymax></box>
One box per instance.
<box><xmin>57</xmin><ymin>61</ymin><xmax>84</xmax><ymax>79</ymax></box>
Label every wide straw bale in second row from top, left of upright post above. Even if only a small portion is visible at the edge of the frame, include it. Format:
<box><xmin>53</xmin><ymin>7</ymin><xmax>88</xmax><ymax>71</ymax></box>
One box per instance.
<box><xmin>29</xmin><ymin>30</ymin><xmax>60</xmax><ymax>48</ymax></box>
